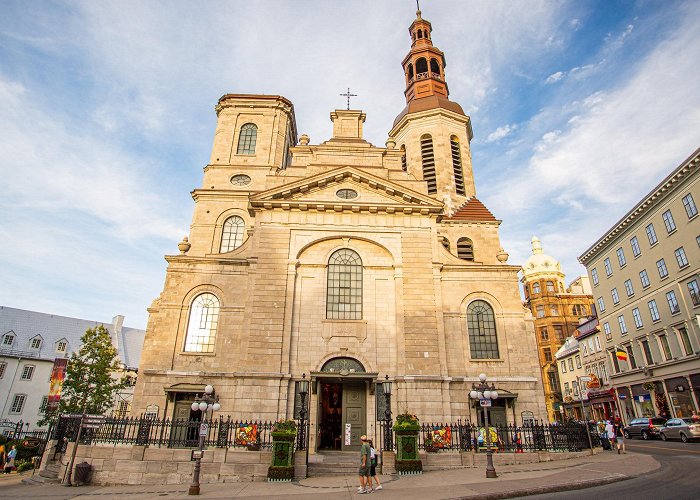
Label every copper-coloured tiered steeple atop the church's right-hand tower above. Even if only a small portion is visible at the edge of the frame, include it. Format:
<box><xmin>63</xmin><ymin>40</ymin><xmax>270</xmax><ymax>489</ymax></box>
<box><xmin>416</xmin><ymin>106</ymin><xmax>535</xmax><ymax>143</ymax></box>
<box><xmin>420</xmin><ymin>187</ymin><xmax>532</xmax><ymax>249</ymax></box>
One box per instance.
<box><xmin>401</xmin><ymin>10</ymin><xmax>449</xmax><ymax>103</ymax></box>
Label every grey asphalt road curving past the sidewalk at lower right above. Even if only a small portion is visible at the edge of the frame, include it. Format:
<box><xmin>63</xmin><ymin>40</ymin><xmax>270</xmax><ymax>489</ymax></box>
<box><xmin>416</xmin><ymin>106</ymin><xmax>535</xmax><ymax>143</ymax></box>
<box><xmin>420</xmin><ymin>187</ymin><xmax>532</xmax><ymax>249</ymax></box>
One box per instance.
<box><xmin>527</xmin><ymin>439</ymin><xmax>700</xmax><ymax>500</ymax></box>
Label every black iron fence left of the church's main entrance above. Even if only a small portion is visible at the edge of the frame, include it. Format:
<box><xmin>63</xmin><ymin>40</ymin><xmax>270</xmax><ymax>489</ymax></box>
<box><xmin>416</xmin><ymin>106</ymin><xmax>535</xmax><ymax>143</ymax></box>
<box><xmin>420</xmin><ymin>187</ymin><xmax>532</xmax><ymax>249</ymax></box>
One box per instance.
<box><xmin>52</xmin><ymin>417</ymin><xmax>274</xmax><ymax>452</ymax></box>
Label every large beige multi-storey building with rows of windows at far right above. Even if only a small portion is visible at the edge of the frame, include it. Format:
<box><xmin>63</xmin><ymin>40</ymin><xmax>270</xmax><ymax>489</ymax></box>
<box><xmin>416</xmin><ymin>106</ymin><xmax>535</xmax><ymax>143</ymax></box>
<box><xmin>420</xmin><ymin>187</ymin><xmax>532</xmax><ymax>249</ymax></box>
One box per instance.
<box><xmin>579</xmin><ymin>149</ymin><xmax>700</xmax><ymax>419</ymax></box>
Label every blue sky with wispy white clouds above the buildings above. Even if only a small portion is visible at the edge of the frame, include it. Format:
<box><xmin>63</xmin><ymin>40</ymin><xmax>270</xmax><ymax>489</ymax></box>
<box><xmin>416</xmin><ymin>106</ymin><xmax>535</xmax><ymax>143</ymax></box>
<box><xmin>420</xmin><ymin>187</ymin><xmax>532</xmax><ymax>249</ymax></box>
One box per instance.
<box><xmin>0</xmin><ymin>0</ymin><xmax>700</xmax><ymax>328</ymax></box>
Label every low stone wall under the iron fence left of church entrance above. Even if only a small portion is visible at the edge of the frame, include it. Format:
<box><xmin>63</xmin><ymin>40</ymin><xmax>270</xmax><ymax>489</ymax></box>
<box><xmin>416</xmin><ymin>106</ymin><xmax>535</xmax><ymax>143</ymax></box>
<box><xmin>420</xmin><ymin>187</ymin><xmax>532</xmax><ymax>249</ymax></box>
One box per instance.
<box><xmin>59</xmin><ymin>443</ymin><xmax>272</xmax><ymax>485</ymax></box>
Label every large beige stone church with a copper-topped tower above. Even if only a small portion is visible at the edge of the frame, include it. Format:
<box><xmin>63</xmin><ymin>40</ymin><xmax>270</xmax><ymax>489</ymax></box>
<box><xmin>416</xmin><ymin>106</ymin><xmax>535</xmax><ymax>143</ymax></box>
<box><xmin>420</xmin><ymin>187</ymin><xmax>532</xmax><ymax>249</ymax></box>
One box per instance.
<box><xmin>134</xmin><ymin>11</ymin><xmax>547</xmax><ymax>453</ymax></box>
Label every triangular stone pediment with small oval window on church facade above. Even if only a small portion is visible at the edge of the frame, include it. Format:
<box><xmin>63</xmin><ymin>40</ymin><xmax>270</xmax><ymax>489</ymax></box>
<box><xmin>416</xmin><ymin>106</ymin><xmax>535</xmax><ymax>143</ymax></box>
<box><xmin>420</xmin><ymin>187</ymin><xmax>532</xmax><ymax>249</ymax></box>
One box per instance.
<box><xmin>250</xmin><ymin>167</ymin><xmax>443</xmax><ymax>215</ymax></box>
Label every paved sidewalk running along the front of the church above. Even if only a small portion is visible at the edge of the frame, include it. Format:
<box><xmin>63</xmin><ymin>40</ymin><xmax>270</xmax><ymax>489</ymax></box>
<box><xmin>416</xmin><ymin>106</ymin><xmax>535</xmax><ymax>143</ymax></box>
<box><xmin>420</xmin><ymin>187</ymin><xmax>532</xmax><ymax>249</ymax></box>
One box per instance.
<box><xmin>9</xmin><ymin>452</ymin><xmax>659</xmax><ymax>500</ymax></box>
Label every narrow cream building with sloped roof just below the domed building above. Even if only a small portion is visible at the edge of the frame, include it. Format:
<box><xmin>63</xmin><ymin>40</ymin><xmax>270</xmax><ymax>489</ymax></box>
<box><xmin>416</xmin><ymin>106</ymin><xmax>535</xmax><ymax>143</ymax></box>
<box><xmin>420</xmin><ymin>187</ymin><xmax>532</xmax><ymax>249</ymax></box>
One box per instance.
<box><xmin>554</xmin><ymin>336</ymin><xmax>590</xmax><ymax>420</ymax></box>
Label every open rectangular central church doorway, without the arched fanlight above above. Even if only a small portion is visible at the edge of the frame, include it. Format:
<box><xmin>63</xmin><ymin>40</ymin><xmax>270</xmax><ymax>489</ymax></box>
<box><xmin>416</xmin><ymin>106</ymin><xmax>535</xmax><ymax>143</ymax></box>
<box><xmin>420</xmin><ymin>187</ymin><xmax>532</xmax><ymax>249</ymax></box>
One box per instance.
<box><xmin>318</xmin><ymin>381</ymin><xmax>367</xmax><ymax>451</ymax></box>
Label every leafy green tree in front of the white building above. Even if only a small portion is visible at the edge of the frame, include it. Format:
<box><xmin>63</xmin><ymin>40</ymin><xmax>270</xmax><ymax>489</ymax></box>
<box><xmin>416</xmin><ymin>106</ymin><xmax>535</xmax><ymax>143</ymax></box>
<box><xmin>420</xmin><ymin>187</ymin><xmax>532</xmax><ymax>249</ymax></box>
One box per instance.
<box><xmin>40</xmin><ymin>325</ymin><xmax>129</xmax><ymax>424</ymax></box>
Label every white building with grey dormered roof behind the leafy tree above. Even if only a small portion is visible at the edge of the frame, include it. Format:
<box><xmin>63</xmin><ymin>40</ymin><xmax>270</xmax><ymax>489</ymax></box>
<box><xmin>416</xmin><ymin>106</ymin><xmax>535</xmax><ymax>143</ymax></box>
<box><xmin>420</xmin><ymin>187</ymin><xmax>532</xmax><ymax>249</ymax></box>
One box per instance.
<box><xmin>0</xmin><ymin>306</ymin><xmax>145</xmax><ymax>429</ymax></box>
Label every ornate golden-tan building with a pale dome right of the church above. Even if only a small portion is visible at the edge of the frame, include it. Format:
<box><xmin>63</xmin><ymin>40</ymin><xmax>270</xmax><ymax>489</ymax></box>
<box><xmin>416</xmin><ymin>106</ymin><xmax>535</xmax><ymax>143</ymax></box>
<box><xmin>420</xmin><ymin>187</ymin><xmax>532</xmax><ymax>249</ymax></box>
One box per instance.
<box><xmin>520</xmin><ymin>237</ymin><xmax>595</xmax><ymax>422</ymax></box>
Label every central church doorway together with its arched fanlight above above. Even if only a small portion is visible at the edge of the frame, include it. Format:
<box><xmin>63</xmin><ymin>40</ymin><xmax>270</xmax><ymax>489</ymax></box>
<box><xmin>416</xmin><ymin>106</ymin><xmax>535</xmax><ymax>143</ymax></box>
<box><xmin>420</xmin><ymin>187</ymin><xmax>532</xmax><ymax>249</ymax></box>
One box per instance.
<box><xmin>316</xmin><ymin>357</ymin><xmax>371</xmax><ymax>451</ymax></box>
